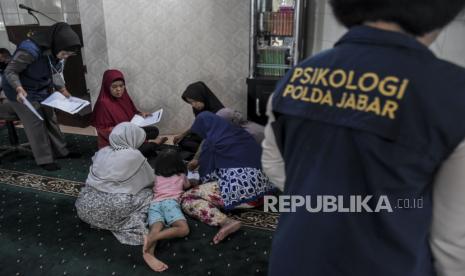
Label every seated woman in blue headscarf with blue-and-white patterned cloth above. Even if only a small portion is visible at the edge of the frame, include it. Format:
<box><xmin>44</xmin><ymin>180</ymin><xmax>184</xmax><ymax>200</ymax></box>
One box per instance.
<box><xmin>181</xmin><ymin>111</ymin><xmax>273</xmax><ymax>243</ymax></box>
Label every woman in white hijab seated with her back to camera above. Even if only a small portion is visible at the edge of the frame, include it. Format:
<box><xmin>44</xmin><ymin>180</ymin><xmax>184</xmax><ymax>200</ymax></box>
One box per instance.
<box><xmin>76</xmin><ymin>122</ymin><xmax>155</xmax><ymax>245</ymax></box>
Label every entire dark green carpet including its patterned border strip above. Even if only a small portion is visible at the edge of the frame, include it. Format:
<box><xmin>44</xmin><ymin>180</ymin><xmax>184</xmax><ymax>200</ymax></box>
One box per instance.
<box><xmin>0</xmin><ymin>126</ymin><xmax>278</xmax><ymax>276</ymax></box>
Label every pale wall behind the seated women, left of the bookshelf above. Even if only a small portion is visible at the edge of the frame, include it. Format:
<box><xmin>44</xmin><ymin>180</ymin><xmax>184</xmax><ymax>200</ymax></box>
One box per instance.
<box><xmin>79</xmin><ymin>0</ymin><xmax>250</xmax><ymax>134</ymax></box>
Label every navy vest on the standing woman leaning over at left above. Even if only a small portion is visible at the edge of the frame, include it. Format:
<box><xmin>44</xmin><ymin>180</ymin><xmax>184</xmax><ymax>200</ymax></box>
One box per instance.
<box><xmin>2</xmin><ymin>39</ymin><xmax>52</xmax><ymax>102</ymax></box>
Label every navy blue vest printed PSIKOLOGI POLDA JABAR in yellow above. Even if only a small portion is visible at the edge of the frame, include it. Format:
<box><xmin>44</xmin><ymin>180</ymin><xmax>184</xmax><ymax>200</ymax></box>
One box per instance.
<box><xmin>269</xmin><ymin>26</ymin><xmax>465</xmax><ymax>276</ymax></box>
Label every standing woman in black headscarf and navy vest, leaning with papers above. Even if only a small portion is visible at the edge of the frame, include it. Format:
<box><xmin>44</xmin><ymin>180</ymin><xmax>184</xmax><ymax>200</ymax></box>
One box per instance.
<box><xmin>2</xmin><ymin>22</ymin><xmax>81</xmax><ymax>170</ymax></box>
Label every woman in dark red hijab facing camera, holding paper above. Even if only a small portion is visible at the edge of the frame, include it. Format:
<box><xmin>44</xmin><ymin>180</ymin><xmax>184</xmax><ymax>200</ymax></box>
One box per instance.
<box><xmin>91</xmin><ymin>69</ymin><xmax>166</xmax><ymax>156</ymax></box>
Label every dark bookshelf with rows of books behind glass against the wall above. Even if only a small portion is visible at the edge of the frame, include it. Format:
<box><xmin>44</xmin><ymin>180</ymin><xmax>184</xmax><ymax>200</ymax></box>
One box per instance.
<box><xmin>247</xmin><ymin>0</ymin><xmax>307</xmax><ymax>124</ymax></box>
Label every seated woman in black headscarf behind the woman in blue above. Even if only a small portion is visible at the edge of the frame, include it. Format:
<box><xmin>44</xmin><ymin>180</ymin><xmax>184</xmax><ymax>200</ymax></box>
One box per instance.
<box><xmin>173</xmin><ymin>81</ymin><xmax>224</xmax><ymax>153</ymax></box>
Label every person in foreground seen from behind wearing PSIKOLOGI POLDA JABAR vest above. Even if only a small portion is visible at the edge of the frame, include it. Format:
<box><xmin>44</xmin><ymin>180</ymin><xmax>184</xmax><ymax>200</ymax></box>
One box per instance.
<box><xmin>263</xmin><ymin>0</ymin><xmax>465</xmax><ymax>276</ymax></box>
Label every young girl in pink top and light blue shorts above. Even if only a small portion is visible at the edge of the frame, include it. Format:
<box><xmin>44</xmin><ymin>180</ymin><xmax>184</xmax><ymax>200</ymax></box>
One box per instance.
<box><xmin>143</xmin><ymin>150</ymin><xmax>190</xmax><ymax>272</ymax></box>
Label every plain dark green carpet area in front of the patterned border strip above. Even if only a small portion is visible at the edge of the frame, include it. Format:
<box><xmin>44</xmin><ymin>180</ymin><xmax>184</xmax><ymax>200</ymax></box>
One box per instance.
<box><xmin>0</xmin><ymin>184</ymin><xmax>272</xmax><ymax>276</ymax></box>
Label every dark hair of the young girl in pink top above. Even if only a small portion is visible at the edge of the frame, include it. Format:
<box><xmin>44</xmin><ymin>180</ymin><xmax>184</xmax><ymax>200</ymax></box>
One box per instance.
<box><xmin>155</xmin><ymin>150</ymin><xmax>187</xmax><ymax>177</ymax></box>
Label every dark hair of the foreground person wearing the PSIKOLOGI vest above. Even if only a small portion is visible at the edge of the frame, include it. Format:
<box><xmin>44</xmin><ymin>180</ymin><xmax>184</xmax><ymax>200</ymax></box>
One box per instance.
<box><xmin>330</xmin><ymin>0</ymin><xmax>465</xmax><ymax>36</ymax></box>
